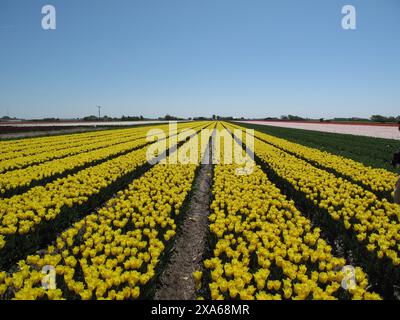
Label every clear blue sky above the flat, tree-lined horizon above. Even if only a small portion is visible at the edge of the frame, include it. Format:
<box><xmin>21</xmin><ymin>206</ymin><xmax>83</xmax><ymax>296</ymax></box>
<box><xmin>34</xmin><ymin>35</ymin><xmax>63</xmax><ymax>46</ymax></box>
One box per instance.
<box><xmin>0</xmin><ymin>0</ymin><xmax>400</xmax><ymax>118</ymax></box>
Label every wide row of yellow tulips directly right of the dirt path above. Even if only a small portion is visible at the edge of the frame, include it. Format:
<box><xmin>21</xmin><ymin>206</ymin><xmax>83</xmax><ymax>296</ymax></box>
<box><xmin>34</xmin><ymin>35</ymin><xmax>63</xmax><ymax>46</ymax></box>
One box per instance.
<box><xmin>200</xmin><ymin>132</ymin><xmax>380</xmax><ymax>300</ymax></box>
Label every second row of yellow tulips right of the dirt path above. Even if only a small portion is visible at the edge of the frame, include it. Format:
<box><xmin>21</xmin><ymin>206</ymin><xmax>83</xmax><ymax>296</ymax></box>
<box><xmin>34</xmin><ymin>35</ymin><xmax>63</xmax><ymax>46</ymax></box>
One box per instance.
<box><xmin>223</xmin><ymin>122</ymin><xmax>400</xmax><ymax>266</ymax></box>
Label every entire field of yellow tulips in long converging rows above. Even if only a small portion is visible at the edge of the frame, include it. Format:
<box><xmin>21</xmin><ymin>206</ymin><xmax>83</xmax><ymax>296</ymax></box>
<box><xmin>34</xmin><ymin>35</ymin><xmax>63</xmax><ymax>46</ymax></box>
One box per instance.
<box><xmin>0</xmin><ymin>121</ymin><xmax>400</xmax><ymax>300</ymax></box>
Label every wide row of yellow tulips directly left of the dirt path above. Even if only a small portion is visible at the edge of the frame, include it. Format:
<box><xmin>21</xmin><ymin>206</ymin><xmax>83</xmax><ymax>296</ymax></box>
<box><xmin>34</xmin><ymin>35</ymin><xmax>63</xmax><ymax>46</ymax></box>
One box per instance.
<box><xmin>0</xmin><ymin>124</ymin><xmax>214</xmax><ymax>300</ymax></box>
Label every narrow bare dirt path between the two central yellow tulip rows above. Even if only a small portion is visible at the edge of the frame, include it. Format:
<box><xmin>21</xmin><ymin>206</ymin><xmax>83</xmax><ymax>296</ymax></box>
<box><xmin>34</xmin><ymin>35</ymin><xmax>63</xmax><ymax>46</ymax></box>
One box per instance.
<box><xmin>154</xmin><ymin>164</ymin><xmax>213</xmax><ymax>300</ymax></box>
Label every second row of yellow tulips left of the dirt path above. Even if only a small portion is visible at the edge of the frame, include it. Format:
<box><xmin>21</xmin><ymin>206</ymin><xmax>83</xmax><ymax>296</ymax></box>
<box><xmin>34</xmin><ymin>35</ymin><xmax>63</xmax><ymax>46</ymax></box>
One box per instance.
<box><xmin>0</xmin><ymin>123</ymin><xmax>208</xmax><ymax>249</ymax></box>
